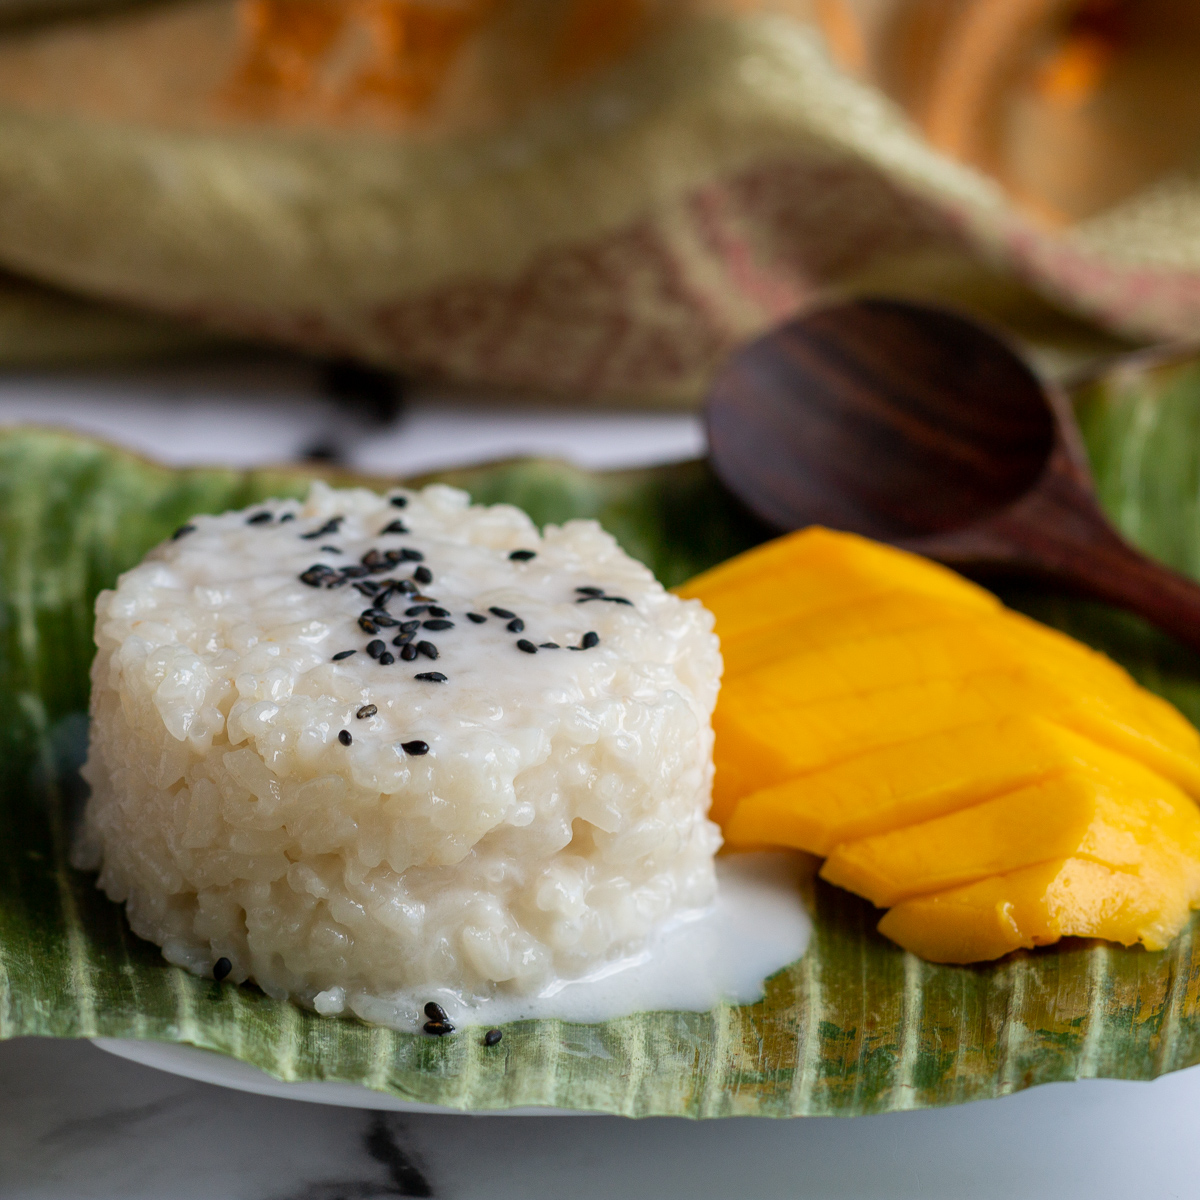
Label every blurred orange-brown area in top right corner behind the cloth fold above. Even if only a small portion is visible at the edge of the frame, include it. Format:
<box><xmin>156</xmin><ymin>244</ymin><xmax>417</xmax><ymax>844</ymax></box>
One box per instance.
<box><xmin>818</xmin><ymin>0</ymin><xmax>1200</xmax><ymax>224</ymax></box>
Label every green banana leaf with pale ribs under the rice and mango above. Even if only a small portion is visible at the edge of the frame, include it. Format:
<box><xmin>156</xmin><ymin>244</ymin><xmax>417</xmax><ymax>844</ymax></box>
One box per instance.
<box><xmin>9</xmin><ymin>350</ymin><xmax>1200</xmax><ymax>1117</ymax></box>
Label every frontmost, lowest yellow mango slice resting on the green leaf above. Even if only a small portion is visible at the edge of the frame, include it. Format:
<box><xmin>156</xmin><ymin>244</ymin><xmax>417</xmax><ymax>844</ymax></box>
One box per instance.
<box><xmin>880</xmin><ymin>858</ymin><xmax>1200</xmax><ymax>962</ymax></box>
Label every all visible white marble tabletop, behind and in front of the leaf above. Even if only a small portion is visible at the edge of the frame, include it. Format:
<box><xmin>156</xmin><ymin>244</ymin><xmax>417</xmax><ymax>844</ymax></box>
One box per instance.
<box><xmin>0</xmin><ymin>364</ymin><xmax>1200</xmax><ymax>1200</ymax></box>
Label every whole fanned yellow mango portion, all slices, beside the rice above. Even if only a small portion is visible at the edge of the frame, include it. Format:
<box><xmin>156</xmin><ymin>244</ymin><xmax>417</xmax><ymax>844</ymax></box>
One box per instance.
<box><xmin>678</xmin><ymin>527</ymin><xmax>1200</xmax><ymax>962</ymax></box>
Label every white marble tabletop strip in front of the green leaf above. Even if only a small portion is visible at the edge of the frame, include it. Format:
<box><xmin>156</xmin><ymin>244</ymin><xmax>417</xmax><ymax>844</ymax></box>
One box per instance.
<box><xmin>7</xmin><ymin>1039</ymin><xmax>1200</xmax><ymax>1200</ymax></box>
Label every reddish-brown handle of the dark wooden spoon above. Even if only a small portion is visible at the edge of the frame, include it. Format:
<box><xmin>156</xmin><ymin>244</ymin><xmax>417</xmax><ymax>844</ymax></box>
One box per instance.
<box><xmin>907</xmin><ymin>456</ymin><xmax>1200</xmax><ymax>650</ymax></box>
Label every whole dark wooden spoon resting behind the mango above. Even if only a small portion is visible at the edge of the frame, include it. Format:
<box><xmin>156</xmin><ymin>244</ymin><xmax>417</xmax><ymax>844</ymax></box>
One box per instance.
<box><xmin>708</xmin><ymin>300</ymin><xmax>1200</xmax><ymax>649</ymax></box>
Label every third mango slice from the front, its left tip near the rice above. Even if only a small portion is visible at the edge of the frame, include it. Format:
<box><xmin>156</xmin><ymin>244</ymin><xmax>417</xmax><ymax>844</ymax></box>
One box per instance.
<box><xmin>725</xmin><ymin>716</ymin><xmax>1152</xmax><ymax>854</ymax></box>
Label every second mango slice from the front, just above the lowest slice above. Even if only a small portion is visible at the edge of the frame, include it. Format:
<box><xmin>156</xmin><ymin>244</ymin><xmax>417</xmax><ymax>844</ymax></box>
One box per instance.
<box><xmin>821</xmin><ymin>767</ymin><xmax>1200</xmax><ymax>907</ymax></box>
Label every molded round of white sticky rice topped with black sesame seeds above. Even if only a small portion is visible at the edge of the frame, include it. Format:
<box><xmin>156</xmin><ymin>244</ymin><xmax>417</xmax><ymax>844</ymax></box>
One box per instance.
<box><xmin>77</xmin><ymin>484</ymin><xmax>721</xmax><ymax>1027</ymax></box>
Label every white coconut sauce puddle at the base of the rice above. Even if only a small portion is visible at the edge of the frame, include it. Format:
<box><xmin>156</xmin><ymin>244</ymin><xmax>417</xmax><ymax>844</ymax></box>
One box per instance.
<box><xmin>347</xmin><ymin>851</ymin><xmax>812</xmax><ymax>1027</ymax></box>
